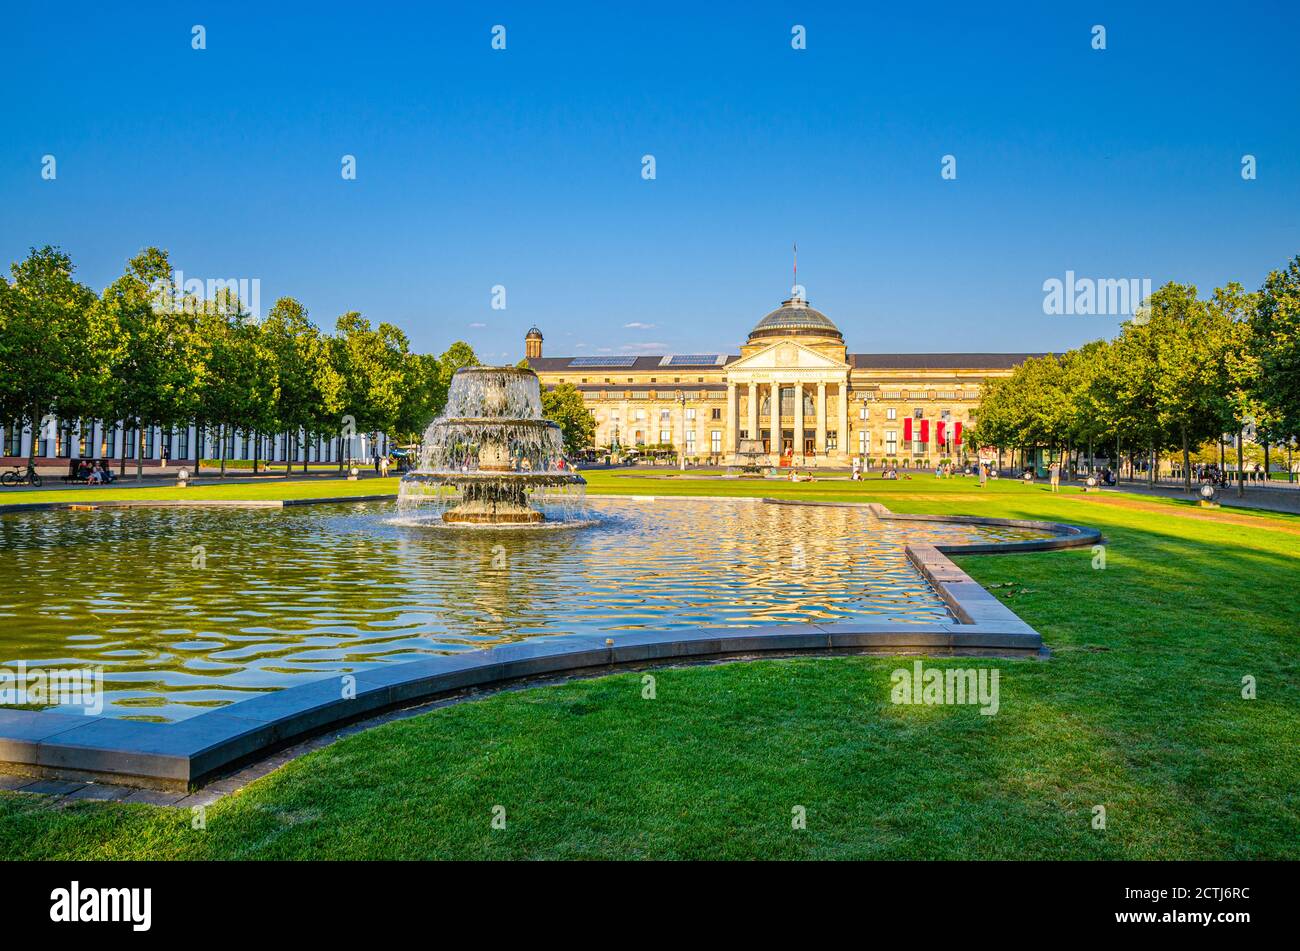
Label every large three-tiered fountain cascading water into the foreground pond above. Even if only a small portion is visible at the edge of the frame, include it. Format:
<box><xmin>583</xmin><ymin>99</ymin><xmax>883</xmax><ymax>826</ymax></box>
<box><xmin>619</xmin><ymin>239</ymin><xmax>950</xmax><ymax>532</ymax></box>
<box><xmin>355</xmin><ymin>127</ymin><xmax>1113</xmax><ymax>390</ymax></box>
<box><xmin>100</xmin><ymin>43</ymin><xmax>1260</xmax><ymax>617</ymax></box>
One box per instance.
<box><xmin>398</xmin><ymin>366</ymin><xmax>586</xmax><ymax>525</ymax></box>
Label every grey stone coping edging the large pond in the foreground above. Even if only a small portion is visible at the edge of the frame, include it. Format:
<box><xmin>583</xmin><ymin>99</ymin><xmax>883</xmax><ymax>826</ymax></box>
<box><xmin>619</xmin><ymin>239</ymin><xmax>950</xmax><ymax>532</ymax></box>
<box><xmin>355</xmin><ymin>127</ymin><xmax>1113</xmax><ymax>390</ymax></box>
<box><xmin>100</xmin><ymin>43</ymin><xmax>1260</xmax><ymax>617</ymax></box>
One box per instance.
<box><xmin>0</xmin><ymin>496</ymin><xmax>1101</xmax><ymax>790</ymax></box>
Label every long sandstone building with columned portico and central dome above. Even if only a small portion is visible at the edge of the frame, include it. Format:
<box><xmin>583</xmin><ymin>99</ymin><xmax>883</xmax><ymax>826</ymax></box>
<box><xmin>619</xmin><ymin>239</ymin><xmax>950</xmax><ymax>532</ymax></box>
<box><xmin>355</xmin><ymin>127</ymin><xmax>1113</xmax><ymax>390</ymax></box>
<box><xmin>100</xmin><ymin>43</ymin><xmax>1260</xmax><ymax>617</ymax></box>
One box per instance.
<box><xmin>527</xmin><ymin>296</ymin><xmax>1034</xmax><ymax>466</ymax></box>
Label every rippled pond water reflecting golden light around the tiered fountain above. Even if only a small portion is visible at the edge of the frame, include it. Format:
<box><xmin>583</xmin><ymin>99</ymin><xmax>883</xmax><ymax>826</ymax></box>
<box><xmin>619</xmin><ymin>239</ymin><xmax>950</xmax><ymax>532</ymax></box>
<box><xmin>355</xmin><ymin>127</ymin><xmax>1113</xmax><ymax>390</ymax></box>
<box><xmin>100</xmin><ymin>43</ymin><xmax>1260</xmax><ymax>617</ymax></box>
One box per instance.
<box><xmin>0</xmin><ymin>499</ymin><xmax>1034</xmax><ymax>720</ymax></box>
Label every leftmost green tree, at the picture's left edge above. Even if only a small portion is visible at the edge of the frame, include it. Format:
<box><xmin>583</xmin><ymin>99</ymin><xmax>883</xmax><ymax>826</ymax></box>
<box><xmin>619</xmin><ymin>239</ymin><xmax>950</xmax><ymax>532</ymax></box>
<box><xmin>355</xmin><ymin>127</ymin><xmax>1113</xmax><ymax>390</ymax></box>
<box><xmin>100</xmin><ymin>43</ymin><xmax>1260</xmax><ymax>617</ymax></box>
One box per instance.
<box><xmin>0</xmin><ymin>247</ymin><xmax>118</xmax><ymax>465</ymax></box>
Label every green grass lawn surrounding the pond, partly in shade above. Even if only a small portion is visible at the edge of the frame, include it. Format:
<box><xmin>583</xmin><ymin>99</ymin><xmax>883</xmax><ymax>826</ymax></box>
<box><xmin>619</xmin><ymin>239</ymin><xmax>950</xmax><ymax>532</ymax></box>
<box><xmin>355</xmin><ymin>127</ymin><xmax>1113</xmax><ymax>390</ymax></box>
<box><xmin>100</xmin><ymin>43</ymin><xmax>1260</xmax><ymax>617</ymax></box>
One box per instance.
<box><xmin>0</xmin><ymin>472</ymin><xmax>1300</xmax><ymax>859</ymax></box>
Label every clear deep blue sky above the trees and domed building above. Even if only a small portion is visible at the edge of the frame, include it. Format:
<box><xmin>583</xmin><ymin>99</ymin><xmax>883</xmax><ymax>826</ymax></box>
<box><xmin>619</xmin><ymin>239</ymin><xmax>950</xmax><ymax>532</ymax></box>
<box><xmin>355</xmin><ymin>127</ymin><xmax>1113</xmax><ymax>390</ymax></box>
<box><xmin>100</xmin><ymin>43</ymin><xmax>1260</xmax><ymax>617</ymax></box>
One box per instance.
<box><xmin>0</xmin><ymin>0</ymin><xmax>1300</xmax><ymax>361</ymax></box>
